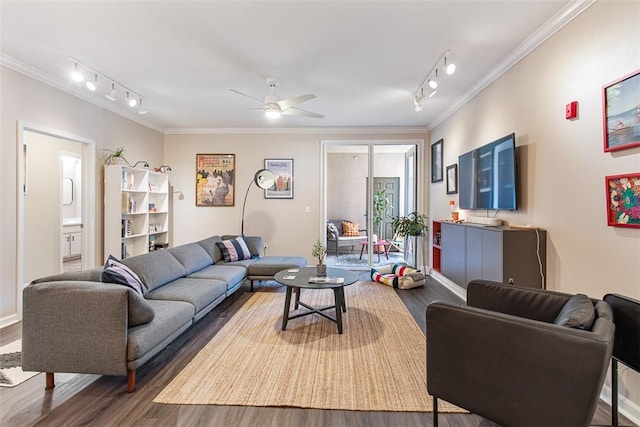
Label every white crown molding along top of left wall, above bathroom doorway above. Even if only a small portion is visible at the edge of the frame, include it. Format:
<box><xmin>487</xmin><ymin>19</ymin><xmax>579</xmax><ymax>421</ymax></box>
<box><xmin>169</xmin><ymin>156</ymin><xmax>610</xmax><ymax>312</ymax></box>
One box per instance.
<box><xmin>0</xmin><ymin>52</ymin><xmax>163</xmax><ymax>133</ymax></box>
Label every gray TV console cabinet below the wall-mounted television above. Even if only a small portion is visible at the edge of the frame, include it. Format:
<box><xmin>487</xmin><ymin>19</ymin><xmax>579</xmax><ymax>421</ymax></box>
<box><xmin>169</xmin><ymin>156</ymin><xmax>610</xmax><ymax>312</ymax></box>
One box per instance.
<box><xmin>440</xmin><ymin>221</ymin><xmax>547</xmax><ymax>289</ymax></box>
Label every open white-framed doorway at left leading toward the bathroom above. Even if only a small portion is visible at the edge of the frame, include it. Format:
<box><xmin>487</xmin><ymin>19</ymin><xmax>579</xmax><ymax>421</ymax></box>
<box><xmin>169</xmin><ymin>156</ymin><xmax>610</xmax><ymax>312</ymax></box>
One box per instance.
<box><xmin>16</xmin><ymin>122</ymin><xmax>95</xmax><ymax>312</ymax></box>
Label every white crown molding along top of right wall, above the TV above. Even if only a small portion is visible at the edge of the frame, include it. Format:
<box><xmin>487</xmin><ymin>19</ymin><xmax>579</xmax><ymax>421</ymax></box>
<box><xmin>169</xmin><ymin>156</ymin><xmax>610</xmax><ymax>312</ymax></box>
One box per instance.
<box><xmin>427</xmin><ymin>0</ymin><xmax>597</xmax><ymax>131</ymax></box>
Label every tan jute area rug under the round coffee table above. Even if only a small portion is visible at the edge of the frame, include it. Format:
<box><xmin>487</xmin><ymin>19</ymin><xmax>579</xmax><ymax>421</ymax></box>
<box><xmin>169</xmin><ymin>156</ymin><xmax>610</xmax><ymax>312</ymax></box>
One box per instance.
<box><xmin>154</xmin><ymin>282</ymin><xmax>465</xmax><ymax>412</ymax></box>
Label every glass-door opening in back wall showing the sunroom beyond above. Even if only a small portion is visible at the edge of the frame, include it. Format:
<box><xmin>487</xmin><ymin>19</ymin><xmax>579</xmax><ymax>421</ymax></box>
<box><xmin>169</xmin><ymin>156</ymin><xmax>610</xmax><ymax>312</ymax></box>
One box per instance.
<box><xmin>320</xmin><ymin>140</ymin><xmax>423</xmax><ymax>270</ymax></box>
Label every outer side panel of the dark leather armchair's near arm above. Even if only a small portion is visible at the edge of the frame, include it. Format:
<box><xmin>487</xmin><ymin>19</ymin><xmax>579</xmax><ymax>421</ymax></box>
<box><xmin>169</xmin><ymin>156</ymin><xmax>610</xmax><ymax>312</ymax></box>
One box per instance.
<box><xmin>426</xmin><ymin>302</ymin><xmax>614</xmax><ymax>425</ymax></box>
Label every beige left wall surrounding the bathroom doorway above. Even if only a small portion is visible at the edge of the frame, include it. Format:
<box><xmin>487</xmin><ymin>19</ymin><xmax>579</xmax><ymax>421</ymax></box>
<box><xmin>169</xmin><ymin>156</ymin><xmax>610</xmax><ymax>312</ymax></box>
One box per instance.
<box><xmin>0</xmin><ymin>66</ymin><xmax>163</xmax><ymax>326</ymax></box>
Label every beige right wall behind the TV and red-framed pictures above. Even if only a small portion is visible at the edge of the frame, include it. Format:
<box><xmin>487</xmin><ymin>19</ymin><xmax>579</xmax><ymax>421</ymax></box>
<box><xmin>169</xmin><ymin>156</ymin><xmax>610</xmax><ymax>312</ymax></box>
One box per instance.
<box><xmin>430</xmin><ymin>1</ymin><xmax>640</xmax><ymax>410</ymax></box>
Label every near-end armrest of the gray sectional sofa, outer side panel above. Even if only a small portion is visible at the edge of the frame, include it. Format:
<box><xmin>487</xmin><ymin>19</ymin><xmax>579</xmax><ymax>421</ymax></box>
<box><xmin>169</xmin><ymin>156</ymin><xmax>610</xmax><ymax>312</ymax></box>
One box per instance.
<box><xmin>22</xmin><ymin>281</ymin><xmax>128</xmax><ymax>375</ymax></box>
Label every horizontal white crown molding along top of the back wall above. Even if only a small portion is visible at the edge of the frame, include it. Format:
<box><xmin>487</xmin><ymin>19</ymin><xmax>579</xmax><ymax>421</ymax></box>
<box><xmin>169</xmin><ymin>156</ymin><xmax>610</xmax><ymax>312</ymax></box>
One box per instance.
<box><xmin>164</xmin><ymin>127</ymin><xmax>428</xmax><ymax>135</ymax></box>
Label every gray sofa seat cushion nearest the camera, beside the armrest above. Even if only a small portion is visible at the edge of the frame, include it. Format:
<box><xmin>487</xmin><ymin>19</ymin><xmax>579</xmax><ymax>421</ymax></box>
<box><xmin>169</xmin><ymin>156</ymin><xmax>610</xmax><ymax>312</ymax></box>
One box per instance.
<box><xmin>127</xmin><ymin>298</ymin><xmax>195</xmax><ymax>362</ymax></box>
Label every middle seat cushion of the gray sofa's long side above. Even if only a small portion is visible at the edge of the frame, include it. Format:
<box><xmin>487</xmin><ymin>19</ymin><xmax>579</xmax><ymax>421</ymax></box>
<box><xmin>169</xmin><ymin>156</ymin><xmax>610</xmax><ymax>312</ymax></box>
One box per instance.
<box><xmin>149</xmin><ymin>277</ymin><xmax>227</xmax><ymax>313</ymax></box>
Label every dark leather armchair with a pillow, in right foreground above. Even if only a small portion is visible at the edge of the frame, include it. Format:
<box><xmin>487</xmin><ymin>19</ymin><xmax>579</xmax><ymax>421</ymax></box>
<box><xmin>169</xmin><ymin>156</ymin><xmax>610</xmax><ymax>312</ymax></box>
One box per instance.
<box><xmin>427</xmin><ymin>280</ymin><xmax>615</xmax><ymax>426</ymax></box>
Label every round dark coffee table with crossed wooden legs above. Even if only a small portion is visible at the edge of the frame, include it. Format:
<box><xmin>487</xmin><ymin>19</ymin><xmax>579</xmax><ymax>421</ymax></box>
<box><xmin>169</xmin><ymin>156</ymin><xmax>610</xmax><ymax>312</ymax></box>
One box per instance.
<box><xmin>275</xmin><ymin>267</ymin><xmax>358</xmax><ymax>334</ymax></box>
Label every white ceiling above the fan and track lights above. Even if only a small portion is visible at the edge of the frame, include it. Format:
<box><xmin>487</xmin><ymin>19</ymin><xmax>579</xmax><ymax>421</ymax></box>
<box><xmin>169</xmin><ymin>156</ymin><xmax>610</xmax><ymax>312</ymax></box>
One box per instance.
<box><xmin>0</xmin><ymin>0</ymin><xmax>593</xmax><ymax>132</ymax></box>
